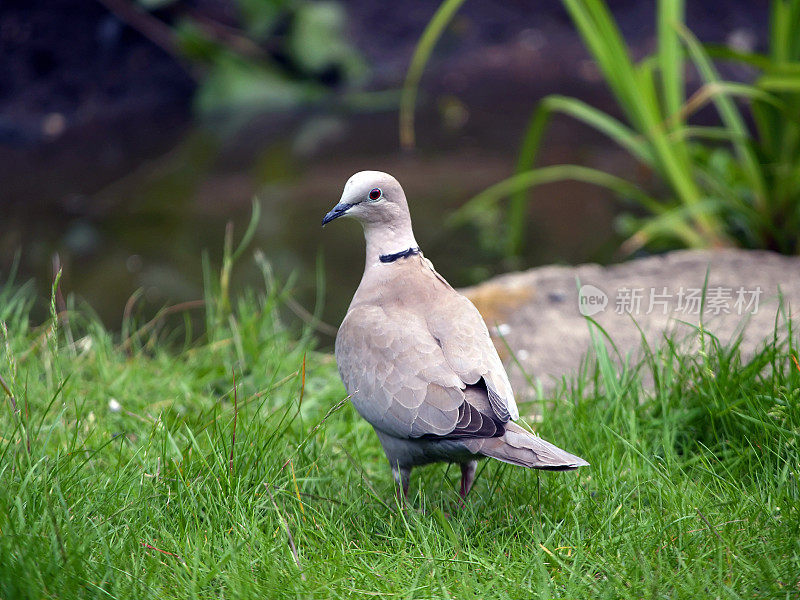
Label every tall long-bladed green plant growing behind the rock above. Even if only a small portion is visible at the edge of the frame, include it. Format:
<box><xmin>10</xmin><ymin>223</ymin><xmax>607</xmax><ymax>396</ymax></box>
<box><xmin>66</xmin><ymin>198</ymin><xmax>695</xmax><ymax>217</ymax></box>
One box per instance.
<box><xmin>406</xmin><ymin>0</ymin><xmax>800</xmax><ymax>258</ymax></box>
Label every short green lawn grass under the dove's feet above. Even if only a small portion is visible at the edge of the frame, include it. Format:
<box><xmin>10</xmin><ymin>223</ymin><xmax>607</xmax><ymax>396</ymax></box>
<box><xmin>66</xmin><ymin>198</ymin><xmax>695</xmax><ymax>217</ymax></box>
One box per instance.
<box><xmin>0</xmin><ymin>258</ymin><xmax>800</xmax><ymax>599</ymax></box>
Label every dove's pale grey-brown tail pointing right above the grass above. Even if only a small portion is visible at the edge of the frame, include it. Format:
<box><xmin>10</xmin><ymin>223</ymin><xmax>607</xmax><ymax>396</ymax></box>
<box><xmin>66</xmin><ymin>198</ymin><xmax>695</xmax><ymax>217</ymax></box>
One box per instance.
<box><xmin>465</xmin><ymin>421</ymin><xmax>589</xmax><ymax>471</ymax></box>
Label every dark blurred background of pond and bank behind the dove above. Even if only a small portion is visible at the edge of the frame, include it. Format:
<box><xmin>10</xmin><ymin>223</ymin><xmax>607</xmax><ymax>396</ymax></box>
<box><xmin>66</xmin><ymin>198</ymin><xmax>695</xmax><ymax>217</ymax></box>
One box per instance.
<box><xmin>0</xmin><ymin>0</ymin><xmax>800</xmax><ymax>344</ymax></box>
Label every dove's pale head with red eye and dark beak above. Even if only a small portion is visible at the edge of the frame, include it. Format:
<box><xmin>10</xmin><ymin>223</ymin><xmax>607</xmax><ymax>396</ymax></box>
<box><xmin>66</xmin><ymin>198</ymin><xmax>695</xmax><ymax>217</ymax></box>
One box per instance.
<box><xmin>322</xmin><ymin>171</ymin><xmax>411</xmax><ymax>228</ymax></box>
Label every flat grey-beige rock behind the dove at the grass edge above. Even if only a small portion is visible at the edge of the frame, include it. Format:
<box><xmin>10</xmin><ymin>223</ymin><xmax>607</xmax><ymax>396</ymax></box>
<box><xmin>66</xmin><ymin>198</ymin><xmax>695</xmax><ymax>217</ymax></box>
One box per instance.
<box><xmin>462</xmin><ymin>249</ymin><xmax>800</xmax><ymax>398</ymax></box>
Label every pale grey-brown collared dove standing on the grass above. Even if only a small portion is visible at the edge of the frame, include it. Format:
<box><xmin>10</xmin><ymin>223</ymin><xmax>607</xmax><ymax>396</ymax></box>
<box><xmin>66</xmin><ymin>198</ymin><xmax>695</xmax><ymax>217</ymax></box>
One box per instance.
<box><xmin>322</xmin><ymin>171</ymin><xmax>589</xmax><ymax>498</ymax></box>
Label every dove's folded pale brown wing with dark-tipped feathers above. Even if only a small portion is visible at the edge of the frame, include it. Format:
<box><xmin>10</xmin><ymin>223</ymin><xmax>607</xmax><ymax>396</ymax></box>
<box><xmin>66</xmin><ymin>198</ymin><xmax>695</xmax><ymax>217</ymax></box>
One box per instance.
<box><xmin>336</xmin><ymin>304</ymin><xmax>513</xmax><ymax>439</ymax></box>
